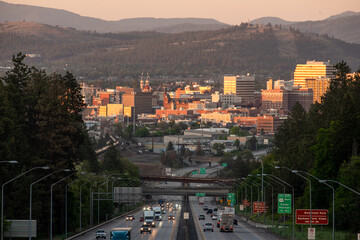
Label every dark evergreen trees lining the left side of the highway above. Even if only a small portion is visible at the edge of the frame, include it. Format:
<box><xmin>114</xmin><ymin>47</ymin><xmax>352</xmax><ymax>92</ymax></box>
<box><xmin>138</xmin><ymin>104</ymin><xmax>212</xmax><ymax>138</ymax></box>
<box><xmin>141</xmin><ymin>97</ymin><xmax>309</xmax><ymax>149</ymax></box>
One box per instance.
<box><xmin>0</xmin><ymin>53</ymin><xmax>139</xmax><ymax>239</ymax></box>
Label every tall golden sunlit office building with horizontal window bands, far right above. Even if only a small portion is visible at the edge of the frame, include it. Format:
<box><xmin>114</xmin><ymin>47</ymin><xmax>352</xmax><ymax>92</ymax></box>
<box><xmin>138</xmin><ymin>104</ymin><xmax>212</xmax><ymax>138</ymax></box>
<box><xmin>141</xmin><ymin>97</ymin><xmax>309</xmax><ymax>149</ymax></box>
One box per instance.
<box><xmin>294</xmin><ymin>61</ymin><xmax>336</xmax><ymax>88</ymax></box>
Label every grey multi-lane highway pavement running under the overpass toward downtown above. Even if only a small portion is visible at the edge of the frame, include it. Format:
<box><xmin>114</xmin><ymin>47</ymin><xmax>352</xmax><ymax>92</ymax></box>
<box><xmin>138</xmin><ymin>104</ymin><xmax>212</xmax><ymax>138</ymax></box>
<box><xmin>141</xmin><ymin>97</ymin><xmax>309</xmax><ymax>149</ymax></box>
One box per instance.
<box><xmin>70</xmin><ymin>162</ymin><xmax>281</xmax><ymax>240</ymax></box>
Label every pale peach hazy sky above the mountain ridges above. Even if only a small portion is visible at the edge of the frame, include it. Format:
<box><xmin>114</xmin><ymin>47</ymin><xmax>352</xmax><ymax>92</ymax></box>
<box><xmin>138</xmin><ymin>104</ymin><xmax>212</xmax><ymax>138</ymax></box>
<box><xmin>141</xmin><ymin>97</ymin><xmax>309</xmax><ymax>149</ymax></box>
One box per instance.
<box><xmin>5</xmin><ymin>0</ymin><xmax>360</xmax><ymax>24</ymax></box>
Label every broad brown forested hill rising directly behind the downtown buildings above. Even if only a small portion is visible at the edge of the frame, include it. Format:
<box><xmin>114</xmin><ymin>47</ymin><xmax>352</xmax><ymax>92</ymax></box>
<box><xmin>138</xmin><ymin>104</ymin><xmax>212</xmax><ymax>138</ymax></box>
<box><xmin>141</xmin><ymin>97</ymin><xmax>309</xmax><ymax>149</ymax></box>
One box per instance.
<box><xmin>0</xmin><ymin>22</ymin><xmax>360</xmax><ymax>78</ymax></box>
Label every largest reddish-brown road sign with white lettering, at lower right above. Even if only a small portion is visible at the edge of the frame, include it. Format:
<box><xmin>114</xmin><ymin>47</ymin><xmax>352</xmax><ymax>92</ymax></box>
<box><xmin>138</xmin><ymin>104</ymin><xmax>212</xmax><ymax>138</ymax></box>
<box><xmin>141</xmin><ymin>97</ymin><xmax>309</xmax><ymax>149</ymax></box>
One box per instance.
<box><xmin>296</xmin><ymin>209</ymin><xmax>329</xmax><ymax>225</ymax></box>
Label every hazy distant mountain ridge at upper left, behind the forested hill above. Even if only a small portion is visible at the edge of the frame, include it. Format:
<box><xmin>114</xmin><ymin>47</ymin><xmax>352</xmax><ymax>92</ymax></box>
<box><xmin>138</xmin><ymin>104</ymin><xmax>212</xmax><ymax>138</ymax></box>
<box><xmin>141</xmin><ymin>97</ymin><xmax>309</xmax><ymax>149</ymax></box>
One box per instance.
<box><xmin>0</xmin><ymin>1</ymin><xmax>228</xmax><ymax>33</ymax></box>
